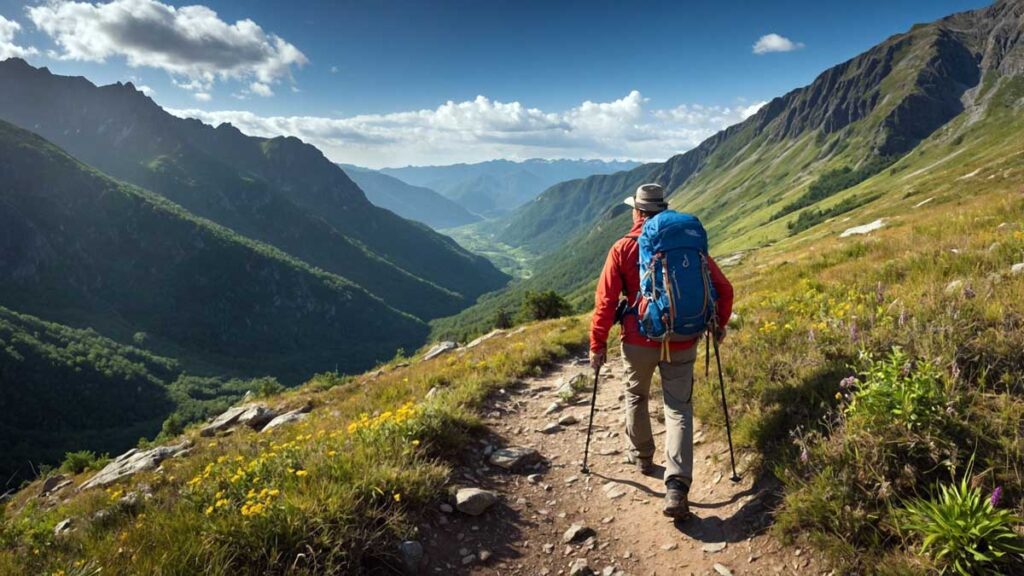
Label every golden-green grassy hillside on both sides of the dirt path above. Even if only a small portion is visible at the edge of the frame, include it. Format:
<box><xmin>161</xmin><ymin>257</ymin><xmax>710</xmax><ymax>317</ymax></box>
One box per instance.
<box><xmin>0</xmin><ymin>155</ymin><xmax>1024</xmax><ymax>574</ymax></box>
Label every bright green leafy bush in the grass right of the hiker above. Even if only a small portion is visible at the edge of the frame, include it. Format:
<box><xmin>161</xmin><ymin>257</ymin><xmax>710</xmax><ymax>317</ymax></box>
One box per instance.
<box><xmin>846</xmin><ymin>347</ymin><xmax>947</xmax><ymax>430</ymax></box>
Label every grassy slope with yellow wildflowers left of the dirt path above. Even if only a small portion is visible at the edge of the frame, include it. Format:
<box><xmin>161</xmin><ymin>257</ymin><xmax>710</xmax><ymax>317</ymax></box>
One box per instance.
<box><xmin>0</xmin><ymin>318</ymin><xmax>585</xmax><ymax>574</ymax></box>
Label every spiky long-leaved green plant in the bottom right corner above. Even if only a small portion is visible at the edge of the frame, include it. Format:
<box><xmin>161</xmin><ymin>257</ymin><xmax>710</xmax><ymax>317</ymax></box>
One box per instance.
<box><xmin>903</xmin><ymin>467</ymin><xmax>1024</xmax><ymax>576</ymax></box>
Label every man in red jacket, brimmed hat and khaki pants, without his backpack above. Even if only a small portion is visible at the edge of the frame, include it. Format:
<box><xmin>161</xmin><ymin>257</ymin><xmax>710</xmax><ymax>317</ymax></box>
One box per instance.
<box><xmin>590</xmin><ymin>183</ymin><xmax>732</xmax><ymax>519</ymax></box>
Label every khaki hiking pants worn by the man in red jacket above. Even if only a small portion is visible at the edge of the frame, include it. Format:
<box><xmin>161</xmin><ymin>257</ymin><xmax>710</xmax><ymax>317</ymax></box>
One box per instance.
<box><xmin>623</xmin><ymin>343</ymin><xmax>697</xmax><ymax>486</ymax></box>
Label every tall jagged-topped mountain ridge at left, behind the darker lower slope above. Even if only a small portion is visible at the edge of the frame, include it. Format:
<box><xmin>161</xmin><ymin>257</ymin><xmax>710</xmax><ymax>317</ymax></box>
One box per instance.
<box><xmin>0</xmin><ymin>58</ymin><xmax>507</xmax><ymax>319</ymax></box>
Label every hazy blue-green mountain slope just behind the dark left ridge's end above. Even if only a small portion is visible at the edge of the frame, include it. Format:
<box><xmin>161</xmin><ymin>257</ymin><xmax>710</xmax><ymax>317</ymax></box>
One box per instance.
<box><xmin>339</xmin><ymin>164</ymin><xmax>480</xmax><ymax>230</ymax></box>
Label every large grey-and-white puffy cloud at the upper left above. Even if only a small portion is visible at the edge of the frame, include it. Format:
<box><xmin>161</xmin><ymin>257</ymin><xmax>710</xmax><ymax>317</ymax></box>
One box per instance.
<box><xmin>27</xmin><ymin>0</ymin><xmax>308</xmax><ymax>93</ymax></box>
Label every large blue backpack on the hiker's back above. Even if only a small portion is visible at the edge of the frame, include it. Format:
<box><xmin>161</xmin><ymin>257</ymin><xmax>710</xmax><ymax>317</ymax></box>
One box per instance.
<box><xmin>637</xmin><ymin>210</ymin><xmax>718</xmax><ymax>344</ymax></box>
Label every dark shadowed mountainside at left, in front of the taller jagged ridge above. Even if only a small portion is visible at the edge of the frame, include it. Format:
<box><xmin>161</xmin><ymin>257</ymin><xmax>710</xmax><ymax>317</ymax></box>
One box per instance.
<box><xmin>0</xmin><ymin>118</ymin><xmax>427</xmax><ymax>383</ymax></box>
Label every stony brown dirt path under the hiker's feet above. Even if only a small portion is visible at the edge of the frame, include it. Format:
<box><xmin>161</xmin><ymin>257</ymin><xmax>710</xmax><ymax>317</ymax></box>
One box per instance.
<box><xmin>413</xmin><ymin>354</ymin><xmax>822</xmax><ymax>576</ymax></box>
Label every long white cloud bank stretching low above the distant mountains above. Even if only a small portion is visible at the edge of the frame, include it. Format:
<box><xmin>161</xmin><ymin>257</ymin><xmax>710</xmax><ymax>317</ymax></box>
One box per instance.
<box><xmin>169</xmin><ymin>90</ymin><xmax>764</xmax><ymax>167</ymax></box>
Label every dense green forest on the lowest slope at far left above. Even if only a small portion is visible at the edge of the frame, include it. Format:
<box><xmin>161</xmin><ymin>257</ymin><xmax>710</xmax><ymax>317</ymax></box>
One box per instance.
<box><xmin>0</xmin><ymin>306</ymin><xmax>253</xmax><ymax>483</ymax></box>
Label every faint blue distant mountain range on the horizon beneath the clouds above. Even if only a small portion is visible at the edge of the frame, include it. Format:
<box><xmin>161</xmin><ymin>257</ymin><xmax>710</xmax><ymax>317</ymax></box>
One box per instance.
<box><xmin>380</xmin><ymin>159</ymin><xmax>637</xmax><ymax>217</ymax></box>
